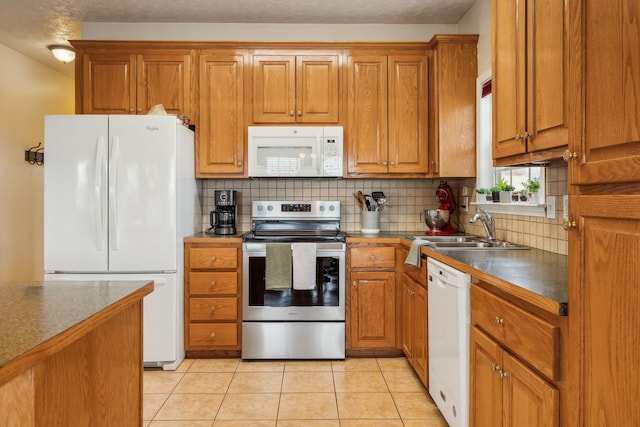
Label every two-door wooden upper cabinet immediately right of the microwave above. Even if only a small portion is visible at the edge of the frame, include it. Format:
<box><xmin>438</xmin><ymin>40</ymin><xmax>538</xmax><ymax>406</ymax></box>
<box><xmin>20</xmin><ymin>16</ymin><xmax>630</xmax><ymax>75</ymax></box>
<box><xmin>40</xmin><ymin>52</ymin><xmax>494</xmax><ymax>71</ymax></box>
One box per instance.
<box><xmin>345</xmin><ymin>51</ymin><xmax>428</xmax><ymax>176</ymax></box>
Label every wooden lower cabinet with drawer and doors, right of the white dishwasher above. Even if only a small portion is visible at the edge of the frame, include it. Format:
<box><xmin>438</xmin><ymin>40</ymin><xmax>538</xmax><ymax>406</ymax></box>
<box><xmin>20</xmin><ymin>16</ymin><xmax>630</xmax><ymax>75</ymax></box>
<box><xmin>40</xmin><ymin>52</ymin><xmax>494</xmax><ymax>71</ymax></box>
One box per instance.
<box><xmin>469</xmin><ymin>285</ymin><xmax>560</xmax><ymax>427</ymax></box>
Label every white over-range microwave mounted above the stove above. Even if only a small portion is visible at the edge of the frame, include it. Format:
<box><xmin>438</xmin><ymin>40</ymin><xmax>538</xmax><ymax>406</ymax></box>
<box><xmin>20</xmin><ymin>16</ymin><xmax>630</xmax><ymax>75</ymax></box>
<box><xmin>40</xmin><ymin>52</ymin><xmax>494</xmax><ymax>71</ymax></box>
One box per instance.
<box><xmin>248</xmin><ymin>126</ymin><xmax>343</xmax><ymax>178</ymax></box>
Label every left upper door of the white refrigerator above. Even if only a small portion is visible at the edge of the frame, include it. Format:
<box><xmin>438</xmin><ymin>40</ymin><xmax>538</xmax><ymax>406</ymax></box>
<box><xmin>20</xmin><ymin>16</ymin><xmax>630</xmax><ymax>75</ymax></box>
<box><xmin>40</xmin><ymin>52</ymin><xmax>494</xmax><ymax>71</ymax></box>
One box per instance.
<box><xmin>44</xmin><ymin>115</ymin><xmax>108</xmax><ymax>271</ymax></box>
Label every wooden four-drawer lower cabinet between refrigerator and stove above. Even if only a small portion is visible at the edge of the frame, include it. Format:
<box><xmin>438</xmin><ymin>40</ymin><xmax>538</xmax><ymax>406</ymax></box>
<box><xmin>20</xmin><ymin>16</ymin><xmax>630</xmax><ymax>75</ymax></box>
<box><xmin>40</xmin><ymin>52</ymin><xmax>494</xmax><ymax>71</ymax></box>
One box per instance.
<box><xmin>184</xmin><ymin>243</ymin><xmax>242</xmax><ymax>357</ymax></box>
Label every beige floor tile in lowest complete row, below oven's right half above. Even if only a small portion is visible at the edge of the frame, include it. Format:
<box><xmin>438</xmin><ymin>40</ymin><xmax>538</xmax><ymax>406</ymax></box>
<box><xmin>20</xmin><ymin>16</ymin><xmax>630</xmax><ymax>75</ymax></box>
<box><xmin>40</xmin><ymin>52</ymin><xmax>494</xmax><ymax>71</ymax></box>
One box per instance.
<box><xmin>278</xmin><ymin>393</ymin><xmax>338</xmax><ymax>420</ymax></box>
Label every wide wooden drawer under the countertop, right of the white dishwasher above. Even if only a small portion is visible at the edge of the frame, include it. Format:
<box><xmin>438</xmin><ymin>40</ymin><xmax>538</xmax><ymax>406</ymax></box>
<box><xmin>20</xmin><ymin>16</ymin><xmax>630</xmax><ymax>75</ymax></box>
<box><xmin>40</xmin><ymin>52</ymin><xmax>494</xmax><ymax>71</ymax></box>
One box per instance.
<box><xmin>471</xmin><ymin>285</ymin><xmax>560</xmax><ymax>380</ymax></box>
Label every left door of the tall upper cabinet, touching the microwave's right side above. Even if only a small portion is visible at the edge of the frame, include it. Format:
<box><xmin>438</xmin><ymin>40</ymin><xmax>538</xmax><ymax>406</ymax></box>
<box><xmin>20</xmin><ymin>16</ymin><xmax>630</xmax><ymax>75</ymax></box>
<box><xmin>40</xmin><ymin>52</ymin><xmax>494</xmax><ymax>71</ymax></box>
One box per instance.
<box><xmin>346</xmin><ymin>56</ymin><xmax>388</xmax><ymax>174</ymax></box>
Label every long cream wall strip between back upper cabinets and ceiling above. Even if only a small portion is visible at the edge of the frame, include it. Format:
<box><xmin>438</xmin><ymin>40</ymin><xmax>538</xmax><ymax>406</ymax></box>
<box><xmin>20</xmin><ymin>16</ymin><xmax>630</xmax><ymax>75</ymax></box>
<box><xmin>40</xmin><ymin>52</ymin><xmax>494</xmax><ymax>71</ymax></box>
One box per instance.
<box><xmin>82</xmin><ymin>22</ymin><xmax>458</xmax><ymax>42</ymax></box>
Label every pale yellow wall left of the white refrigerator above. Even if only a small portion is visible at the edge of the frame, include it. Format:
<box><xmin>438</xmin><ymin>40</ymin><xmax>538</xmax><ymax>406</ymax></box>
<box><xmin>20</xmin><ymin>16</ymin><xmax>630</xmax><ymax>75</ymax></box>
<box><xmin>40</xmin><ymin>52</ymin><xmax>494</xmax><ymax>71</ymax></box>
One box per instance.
<box><xmin>0</xmin><ymin>44</ymin><xmax>75</xmax><ymax>281</ymax></box>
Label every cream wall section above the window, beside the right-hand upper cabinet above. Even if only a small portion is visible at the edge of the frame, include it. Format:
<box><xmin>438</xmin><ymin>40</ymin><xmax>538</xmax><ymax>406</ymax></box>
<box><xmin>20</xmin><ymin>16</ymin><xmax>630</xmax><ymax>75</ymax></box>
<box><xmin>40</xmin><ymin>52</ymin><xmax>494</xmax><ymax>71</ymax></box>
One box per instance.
<box><xmin>458</xmin><ymin>0</ymin><xmax>491</xmax><ymax>75</ymax></box>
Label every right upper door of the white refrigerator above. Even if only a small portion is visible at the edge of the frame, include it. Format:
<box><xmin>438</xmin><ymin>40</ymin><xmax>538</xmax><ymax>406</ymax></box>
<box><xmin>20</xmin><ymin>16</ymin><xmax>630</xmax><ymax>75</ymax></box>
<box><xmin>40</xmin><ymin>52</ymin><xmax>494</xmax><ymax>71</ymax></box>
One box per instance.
<box><xmin>109</xmin><ymin>115</ymin><xmax>181</xmax><ymax>272</ymax></box>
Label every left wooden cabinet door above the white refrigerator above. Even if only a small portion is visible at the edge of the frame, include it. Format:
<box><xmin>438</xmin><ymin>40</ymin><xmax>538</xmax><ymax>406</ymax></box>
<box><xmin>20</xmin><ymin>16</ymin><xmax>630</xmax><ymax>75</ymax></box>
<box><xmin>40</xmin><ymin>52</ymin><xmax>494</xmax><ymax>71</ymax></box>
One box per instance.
<box><xmin>78</xmin><ymin>53</ymin><xmax>136</xmax><ymax>114</ymax></box>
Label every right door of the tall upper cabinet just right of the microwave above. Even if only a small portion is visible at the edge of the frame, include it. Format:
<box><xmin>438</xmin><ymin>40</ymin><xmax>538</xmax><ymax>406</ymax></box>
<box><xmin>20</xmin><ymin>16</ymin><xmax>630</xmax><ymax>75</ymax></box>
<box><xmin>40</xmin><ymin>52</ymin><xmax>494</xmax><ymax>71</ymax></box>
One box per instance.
<box><xmin>388</xmin><ymin>55</ymin><xmax>428</xmax><ymax>173</ymax></box>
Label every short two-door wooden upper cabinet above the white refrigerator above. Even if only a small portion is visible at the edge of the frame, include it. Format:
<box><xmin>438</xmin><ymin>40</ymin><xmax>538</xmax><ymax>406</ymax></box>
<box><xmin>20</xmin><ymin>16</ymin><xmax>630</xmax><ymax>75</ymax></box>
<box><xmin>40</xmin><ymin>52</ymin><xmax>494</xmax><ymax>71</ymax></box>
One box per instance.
<box><xmin>74</xmin><ymin>48</ymin><xmax>191</xmax><ymax>116</ymax></box>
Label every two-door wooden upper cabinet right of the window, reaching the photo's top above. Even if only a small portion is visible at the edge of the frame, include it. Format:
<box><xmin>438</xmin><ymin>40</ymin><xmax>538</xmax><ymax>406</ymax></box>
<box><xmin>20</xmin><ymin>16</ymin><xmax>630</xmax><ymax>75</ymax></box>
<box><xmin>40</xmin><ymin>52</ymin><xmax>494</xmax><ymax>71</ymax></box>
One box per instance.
<box><xmin>492</xmin><ymin>0</ymin><xmax>568</xmax><ymax>165</ymax></box>
